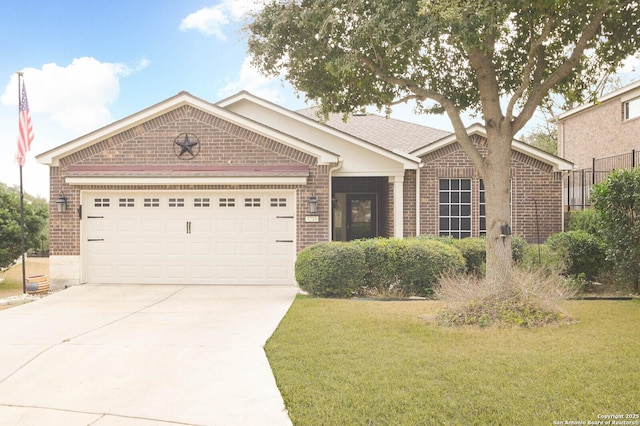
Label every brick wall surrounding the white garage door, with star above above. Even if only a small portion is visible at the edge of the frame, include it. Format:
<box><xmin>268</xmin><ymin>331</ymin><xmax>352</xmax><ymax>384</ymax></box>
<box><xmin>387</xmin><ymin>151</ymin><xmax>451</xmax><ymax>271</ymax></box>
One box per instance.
<box><xmin>50</xmin><ymin>106</ymin><xmax>331</xmax><ymax>255</ymax></box>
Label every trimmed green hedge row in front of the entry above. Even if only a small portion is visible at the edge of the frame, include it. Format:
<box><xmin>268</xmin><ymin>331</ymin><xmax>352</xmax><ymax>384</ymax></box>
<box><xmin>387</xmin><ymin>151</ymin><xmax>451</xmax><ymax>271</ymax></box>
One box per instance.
<box><xmin>296</xmin><ymin>238</ymin><xmax>465</xmax><ymax>297</ymax></box>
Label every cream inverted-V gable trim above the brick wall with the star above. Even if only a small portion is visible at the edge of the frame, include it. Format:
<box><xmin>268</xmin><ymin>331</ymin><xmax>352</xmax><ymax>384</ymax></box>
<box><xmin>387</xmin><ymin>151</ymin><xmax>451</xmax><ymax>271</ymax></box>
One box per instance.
<box><xmin>36</xmin><ymin>91</ymin><xmax>340</xmax><ymax>166</ymax></box>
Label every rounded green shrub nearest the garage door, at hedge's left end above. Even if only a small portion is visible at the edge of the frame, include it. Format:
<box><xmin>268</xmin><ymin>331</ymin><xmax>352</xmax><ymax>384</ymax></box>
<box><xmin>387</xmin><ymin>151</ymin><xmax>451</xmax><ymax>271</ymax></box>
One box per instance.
<box><xmin>295</xmin><ymin>242</ymin><xmax>366</xmax><ymax>297</ymax></box>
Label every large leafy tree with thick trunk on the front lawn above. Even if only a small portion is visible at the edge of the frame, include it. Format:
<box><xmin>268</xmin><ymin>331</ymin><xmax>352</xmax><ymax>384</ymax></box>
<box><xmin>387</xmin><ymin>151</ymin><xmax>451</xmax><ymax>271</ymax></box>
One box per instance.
<box><xmin>247</xmin><ymin>0</ymin><xmax>640</xmax><ymax>280</ymax></box>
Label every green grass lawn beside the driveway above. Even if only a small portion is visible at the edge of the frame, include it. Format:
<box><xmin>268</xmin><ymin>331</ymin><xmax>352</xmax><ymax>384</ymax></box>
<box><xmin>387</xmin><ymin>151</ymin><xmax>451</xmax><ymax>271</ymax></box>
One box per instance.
<box><xmin>265</xmin><ymin>297</ymin><xmax>640</xmax><ymax>425</ymax></box>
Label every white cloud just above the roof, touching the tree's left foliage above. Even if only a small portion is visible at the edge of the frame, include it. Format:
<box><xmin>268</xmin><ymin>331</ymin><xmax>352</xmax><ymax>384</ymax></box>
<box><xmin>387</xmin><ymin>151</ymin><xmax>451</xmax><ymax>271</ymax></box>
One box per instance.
<box><xmin>218</xmin><ymin>57</ymin><xmax>286</xmax><ymax>104</ymax></box>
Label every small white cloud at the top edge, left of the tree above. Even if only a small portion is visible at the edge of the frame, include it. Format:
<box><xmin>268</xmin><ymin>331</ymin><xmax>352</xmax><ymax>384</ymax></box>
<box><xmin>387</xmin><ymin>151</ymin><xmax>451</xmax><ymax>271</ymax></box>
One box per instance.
<box><xmin>179</xmin><ymin>0</ymin><xmax>261</xmax><ymax>40</ymax></box>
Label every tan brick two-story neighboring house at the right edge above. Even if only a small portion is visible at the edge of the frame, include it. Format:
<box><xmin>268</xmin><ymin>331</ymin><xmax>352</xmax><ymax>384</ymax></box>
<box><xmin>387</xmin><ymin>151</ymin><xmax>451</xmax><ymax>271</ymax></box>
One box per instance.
<box><xmin>557</xmin><ymin>81</ymin><xmax>640</xmax><ymax>171</ymax></box>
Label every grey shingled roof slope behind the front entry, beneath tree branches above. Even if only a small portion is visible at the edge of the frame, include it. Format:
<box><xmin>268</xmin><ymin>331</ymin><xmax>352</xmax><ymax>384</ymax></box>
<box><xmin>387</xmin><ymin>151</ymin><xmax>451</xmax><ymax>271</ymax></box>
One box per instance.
<box><xmin>297</xmin><ymin>107</ymin><xmax>451</xmax><ymax>153</ymax></box>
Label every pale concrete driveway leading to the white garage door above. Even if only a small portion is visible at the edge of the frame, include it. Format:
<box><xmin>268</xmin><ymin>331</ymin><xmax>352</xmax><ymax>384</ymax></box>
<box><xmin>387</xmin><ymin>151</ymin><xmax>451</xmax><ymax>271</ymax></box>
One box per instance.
<box><xmin>0</xmin><ymin>285</ymin><xmax>298</xmax><ymax>426</ymax></box>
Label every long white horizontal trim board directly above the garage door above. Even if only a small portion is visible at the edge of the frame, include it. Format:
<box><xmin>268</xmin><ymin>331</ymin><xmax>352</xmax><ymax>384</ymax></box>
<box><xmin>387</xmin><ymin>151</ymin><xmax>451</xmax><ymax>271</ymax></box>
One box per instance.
<box><xmin>65</xmin><ymin>176</ymin><xmax>307</xmax><ymax>186</ymax></box>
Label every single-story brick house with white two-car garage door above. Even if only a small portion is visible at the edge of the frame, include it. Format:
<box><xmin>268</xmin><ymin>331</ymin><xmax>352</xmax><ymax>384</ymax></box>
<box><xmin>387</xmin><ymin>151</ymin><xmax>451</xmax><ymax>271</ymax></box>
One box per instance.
<box><xmin>37</xmin><ymin>92</ymin><xmax>572</xmax><ymax>288</ymax></box>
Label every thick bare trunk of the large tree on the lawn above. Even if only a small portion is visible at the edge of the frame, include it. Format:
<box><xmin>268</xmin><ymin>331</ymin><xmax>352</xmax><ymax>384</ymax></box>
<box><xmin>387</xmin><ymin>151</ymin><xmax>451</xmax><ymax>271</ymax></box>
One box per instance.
<box><xmin>483</xmin><ymin>128</ymin><xmax>513</xmax><ymax>283</ymax></box>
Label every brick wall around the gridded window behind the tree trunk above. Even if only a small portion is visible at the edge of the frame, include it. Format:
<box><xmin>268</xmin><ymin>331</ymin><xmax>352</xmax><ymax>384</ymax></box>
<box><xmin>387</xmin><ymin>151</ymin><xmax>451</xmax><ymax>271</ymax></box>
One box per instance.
<box><xmin>420</xmin><ymin>138</ymin><xmax>562</xmax><ymax>242</ymax></box>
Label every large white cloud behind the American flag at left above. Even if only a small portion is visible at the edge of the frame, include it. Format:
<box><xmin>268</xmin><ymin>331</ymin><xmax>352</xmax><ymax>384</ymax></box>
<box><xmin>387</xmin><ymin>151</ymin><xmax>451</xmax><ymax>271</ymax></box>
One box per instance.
<box><xmin>0</xmin><ymin>57</ymin><xmax>149</xmax><ymax>196</ymax></box>
